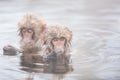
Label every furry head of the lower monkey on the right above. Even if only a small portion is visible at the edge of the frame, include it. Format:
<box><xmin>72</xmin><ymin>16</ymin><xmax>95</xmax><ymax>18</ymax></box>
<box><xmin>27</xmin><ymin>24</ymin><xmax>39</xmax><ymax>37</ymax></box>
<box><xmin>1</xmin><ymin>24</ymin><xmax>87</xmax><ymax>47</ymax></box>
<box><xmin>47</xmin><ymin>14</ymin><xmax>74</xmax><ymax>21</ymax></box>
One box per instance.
<box><xmin>45</xmin><ymin>25</ymin><xmax>72</xmax><ymax>52</ymax></box>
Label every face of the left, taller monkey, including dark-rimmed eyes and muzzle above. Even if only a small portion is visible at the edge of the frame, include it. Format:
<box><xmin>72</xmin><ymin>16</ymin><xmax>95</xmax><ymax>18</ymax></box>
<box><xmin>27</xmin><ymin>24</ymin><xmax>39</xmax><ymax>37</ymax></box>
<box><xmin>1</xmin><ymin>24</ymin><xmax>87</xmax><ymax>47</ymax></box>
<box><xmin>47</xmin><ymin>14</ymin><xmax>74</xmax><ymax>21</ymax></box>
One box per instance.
<box><xmin>21</xmin><ymin>28</ymin><xmax>35</xmax><ymax>41</ymax></box>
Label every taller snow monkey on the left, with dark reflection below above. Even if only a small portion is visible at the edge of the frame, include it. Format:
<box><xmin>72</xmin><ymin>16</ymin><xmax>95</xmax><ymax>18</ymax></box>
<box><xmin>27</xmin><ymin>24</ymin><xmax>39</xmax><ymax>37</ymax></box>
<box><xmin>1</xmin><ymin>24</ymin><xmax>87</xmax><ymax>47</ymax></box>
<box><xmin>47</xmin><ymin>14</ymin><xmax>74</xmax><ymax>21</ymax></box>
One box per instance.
<box><xmin>18</xmin><ymin>14</ymin><xmax>46</xmax><ymax>67</ymax></box>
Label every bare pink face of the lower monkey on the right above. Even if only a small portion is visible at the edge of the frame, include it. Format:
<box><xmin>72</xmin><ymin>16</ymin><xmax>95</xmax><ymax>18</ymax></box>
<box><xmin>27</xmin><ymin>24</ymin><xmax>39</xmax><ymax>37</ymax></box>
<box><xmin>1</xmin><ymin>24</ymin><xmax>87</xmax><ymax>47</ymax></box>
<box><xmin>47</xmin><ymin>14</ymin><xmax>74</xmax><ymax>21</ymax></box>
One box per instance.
<box><xmin>52</xmin><ymin>37</ymin><xmax>65</xmax><ymax>48</ymax></box>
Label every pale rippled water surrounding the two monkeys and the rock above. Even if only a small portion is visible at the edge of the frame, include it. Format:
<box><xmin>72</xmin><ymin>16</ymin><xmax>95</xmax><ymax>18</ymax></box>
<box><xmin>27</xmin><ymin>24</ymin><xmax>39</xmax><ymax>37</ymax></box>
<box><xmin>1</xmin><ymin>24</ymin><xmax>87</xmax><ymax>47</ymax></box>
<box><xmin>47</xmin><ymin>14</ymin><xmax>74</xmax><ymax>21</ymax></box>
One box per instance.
<box><xmin>0</xmin><ymin>0</ymin><xmax>120</xmax><ymax>80</ymax></box>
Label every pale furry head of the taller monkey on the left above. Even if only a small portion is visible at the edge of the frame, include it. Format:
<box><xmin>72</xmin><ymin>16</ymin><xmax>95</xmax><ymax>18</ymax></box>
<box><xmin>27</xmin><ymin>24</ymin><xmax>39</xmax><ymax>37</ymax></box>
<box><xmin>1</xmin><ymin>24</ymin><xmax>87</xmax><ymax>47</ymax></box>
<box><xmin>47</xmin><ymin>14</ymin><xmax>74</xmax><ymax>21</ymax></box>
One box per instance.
<box><xmin>18</xmin><ymin>14</ymin><xmax>46</xmax><ymax>41</ymax></box>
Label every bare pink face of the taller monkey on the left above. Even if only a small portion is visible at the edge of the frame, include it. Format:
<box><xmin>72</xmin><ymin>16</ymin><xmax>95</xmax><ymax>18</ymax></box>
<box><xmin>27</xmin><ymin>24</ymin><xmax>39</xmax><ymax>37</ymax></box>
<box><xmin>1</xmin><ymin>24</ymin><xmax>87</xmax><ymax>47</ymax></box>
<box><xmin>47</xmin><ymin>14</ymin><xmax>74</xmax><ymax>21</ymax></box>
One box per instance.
<box><xmin>22</xmin><ymin>28</ymin><xmax>34</xmax><ymax>40</ymax></box>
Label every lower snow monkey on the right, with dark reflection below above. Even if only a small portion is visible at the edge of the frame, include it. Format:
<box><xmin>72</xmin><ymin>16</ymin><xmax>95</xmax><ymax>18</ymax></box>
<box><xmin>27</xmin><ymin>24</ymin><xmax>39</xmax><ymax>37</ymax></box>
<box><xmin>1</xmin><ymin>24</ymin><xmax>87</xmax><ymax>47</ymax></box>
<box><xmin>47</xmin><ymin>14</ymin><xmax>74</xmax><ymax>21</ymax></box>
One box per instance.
<box><xmin>45</xmin><ymin>25</ymin><xmax>72</xmax><ymax>73</ymax></box>
